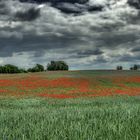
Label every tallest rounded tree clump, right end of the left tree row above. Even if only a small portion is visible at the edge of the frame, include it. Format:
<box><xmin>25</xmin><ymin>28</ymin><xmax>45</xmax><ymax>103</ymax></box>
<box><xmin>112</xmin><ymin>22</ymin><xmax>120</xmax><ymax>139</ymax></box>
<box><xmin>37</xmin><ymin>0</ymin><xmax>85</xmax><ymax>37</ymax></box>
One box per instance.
<box><xmin>47</xmin><ymin>61</ymin><xmax>69</xmax><ymax>71</ymax></box>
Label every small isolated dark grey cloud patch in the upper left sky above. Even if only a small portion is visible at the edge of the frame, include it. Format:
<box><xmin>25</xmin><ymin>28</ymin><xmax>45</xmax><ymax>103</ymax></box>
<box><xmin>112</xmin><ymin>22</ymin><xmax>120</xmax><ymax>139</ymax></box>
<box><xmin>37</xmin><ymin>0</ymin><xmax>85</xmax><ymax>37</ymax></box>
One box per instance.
<box><xmin>15</xmin><ymin>8</ymin><xmax>40</xmax><ymax>21</ymax></box>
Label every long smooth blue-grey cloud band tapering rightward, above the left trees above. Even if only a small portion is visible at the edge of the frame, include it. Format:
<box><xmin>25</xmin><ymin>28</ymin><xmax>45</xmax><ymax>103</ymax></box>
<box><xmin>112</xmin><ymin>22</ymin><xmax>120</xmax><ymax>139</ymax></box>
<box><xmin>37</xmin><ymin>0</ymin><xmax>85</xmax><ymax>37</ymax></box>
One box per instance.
<box><xmin>0</xmin><ymin>33</ymin><xmax>86</xmax><ymax>57</ymax></box>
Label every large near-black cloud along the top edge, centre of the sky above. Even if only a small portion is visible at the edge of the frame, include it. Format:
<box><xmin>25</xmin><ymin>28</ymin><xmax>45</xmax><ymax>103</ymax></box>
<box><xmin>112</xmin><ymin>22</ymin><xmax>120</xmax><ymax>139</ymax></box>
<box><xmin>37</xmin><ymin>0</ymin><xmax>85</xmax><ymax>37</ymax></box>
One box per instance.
<box><xmin>20</xmin><ymin>0</ymin><xmax>103</xmax><ymax>14</ymax></box>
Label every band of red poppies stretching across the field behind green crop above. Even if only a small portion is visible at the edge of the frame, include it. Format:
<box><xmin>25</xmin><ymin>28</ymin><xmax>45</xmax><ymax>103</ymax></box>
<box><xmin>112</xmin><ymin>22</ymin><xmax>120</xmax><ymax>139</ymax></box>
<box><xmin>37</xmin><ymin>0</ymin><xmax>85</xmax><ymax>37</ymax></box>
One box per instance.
<box><xmin>0</xmin><ymin>71</ymin><xmax>140</xmax><ymax>99</ymax></box>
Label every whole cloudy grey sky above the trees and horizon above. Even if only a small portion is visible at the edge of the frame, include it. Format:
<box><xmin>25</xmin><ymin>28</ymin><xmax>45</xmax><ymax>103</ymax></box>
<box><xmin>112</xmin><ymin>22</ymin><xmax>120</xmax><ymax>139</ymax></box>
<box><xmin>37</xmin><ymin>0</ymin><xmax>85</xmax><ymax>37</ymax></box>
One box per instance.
<box><xmin>0</xmin><ymin>0</ymin><xmax>140</xmax><ymax>70</ymax></box>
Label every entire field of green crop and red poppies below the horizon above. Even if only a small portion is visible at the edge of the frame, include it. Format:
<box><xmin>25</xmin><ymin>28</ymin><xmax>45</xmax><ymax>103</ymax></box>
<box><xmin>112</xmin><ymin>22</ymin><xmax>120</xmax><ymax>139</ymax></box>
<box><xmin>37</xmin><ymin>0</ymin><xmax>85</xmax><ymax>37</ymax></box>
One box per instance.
<box><xmin>0</xmin><ymin>71</ymin><xmax>140</xmax><ymax>140</ymax></box>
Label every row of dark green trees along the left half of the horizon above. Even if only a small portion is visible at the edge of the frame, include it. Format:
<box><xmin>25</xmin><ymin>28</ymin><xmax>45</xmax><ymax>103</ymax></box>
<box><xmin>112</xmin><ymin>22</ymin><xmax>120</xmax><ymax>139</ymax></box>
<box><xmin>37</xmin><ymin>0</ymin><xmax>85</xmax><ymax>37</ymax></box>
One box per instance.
<box><xmin>0</xmin><ymin>61</ymin><xmax>69</xmax><ymax>73</ymax></box>
